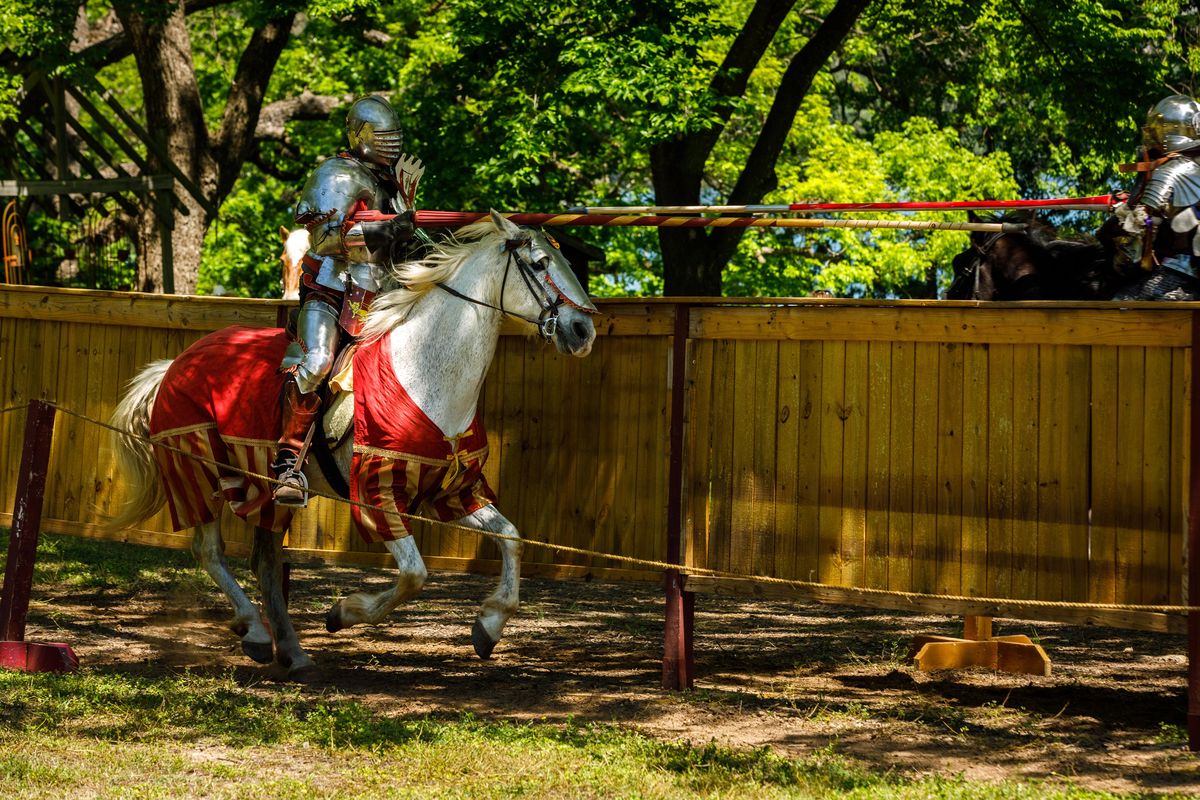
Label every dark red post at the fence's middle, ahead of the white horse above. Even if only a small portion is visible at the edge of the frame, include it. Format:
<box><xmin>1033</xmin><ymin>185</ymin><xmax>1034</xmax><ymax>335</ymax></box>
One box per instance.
<box><xmin>662</xmin><ymin>303</ymin><xmax>695</xmax><ymax>691</ymax></box>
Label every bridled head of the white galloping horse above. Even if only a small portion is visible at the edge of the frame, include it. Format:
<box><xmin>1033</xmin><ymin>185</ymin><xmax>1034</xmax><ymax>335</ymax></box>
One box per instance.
<box><xmin>492</xmin><ymin>211</ymin><xmax>596</xmax><ymax>356</ymax></box>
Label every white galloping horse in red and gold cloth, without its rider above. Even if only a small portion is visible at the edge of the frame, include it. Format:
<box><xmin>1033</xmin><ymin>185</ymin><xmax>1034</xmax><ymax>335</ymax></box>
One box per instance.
<box><xmin>109</xmin><ymin>212</ymin><xmax>595</xmax><ymax>678</ymax></box>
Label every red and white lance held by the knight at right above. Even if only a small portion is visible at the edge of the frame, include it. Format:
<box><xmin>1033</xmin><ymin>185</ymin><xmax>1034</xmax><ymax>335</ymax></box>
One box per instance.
<box><xmin>569</xmin><ymin>194</ymin><xmax>1114</xmax><ymax>215</ymax></box>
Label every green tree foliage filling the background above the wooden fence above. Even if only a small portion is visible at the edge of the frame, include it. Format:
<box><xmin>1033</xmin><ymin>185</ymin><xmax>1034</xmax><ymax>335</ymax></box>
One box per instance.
<box><xmin>0</xmin><ymin>0</ymin><xmax>1200</xmax><ymax>296</ymax></box>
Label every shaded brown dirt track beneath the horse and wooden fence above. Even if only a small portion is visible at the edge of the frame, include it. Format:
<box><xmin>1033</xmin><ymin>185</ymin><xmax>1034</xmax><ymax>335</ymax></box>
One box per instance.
<box><xmin>21</xmin><ymin>566</ymin><xmax>1200</xmax><ymax>794</ymax></box>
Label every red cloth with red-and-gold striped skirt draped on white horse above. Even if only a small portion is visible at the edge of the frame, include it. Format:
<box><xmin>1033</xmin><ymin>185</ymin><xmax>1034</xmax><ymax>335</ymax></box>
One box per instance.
<box><xmin>150</xmin><ymin>326</ymin><xmax>496</xmax><ymax>542</ymax></box>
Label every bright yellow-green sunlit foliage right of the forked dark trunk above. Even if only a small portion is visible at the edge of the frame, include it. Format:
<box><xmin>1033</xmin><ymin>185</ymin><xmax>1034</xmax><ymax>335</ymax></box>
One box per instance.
<box><xmin>725</xmin><ymin>108</ymin><xmax>1018</xmax><ymax>297</ymax></box>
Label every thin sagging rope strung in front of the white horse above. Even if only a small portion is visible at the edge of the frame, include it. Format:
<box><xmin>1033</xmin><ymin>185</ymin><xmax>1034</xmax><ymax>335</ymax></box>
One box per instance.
<box><xmin>39</xmin><ymin>402</ymin><xmax>1200</xmax><ymax>614</ymax></box>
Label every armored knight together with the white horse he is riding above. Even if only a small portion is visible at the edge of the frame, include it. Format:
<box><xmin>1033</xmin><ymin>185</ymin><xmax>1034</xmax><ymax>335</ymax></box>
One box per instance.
<box><xmin>109</xmin><ymin>100</ymin><xmax>596</xmax><ymax>676</ymax></box>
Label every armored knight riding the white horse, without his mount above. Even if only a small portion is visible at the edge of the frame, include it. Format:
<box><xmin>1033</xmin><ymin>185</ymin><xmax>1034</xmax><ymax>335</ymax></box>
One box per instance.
<box><xmin>271</xmin><ymin>96</ymin><xmax>422</xmax><ymax>506</ymax></box>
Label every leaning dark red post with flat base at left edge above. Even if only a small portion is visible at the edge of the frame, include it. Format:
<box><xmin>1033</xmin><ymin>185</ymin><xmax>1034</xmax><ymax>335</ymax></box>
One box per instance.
<box><xmin>0</xmin><ymin>401</ymin><xmax>79</xmax><ymax>672</ymax></box>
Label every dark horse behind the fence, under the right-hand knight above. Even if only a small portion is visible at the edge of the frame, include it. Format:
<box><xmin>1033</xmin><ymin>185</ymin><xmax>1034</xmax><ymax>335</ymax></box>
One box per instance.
<box><xmin>946</xmin><ymin>212</ymin><xmax>1198</xmax><ymax>300</ymax></box>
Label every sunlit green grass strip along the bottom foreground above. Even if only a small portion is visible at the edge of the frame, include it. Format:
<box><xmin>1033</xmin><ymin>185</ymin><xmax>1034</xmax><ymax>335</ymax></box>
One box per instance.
<box><xmin>0</xmin><ymin>670</ymin><xmax>1123</xmax><ymax>799</ymax></box>
